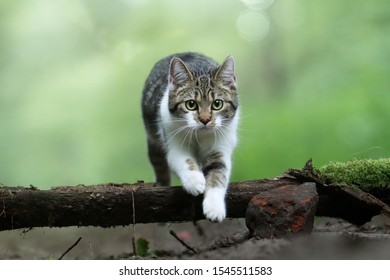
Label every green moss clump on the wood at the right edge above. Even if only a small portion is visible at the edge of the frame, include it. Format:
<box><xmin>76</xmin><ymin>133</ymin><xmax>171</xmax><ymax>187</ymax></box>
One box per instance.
<box><xmin>319</xmin><ymin>158</ymin><xmax>390</xmax><ymax>190</ymax></box>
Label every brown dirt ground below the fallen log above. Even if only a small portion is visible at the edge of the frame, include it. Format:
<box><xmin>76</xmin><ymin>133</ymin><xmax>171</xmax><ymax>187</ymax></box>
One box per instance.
<box><xmin>0</xmin><ymin>216</ymin><xmax>390</xmax><ymax>260</ymax></box>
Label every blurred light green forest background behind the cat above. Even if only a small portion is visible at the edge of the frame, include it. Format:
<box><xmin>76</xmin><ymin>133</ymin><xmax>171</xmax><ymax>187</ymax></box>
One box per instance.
<box><xmin>0</xmin><ymin>0</ymin><xmax>390</xmax><ymax>188</ymax></box>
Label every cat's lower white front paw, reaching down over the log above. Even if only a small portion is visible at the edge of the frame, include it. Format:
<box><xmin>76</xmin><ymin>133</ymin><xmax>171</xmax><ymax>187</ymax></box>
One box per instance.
<box><xmin>203</xmin><ymin>188</ymin><xmax>226</xmax><ymax>222</ymax></box>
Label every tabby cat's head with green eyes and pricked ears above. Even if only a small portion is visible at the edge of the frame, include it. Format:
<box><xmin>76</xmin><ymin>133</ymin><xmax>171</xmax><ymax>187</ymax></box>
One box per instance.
<box><xmin>168</xmin><ymin>56</ymin><xmax>238</xmax><ymax>129</ymax></box>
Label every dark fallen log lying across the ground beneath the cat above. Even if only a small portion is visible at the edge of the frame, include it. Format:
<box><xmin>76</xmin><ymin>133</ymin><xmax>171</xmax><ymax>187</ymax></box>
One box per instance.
<box><xmin>0</xmin><ymin>174</ymin><xmax>390</xmax><ymax>231</ymax></box>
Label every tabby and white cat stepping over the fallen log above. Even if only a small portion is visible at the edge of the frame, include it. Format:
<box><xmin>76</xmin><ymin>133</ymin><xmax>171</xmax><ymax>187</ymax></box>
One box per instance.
<box><xmin>142</xmin><ymin>52</ymin><xmax>239</xmax><ymax>222</ymax></box>
